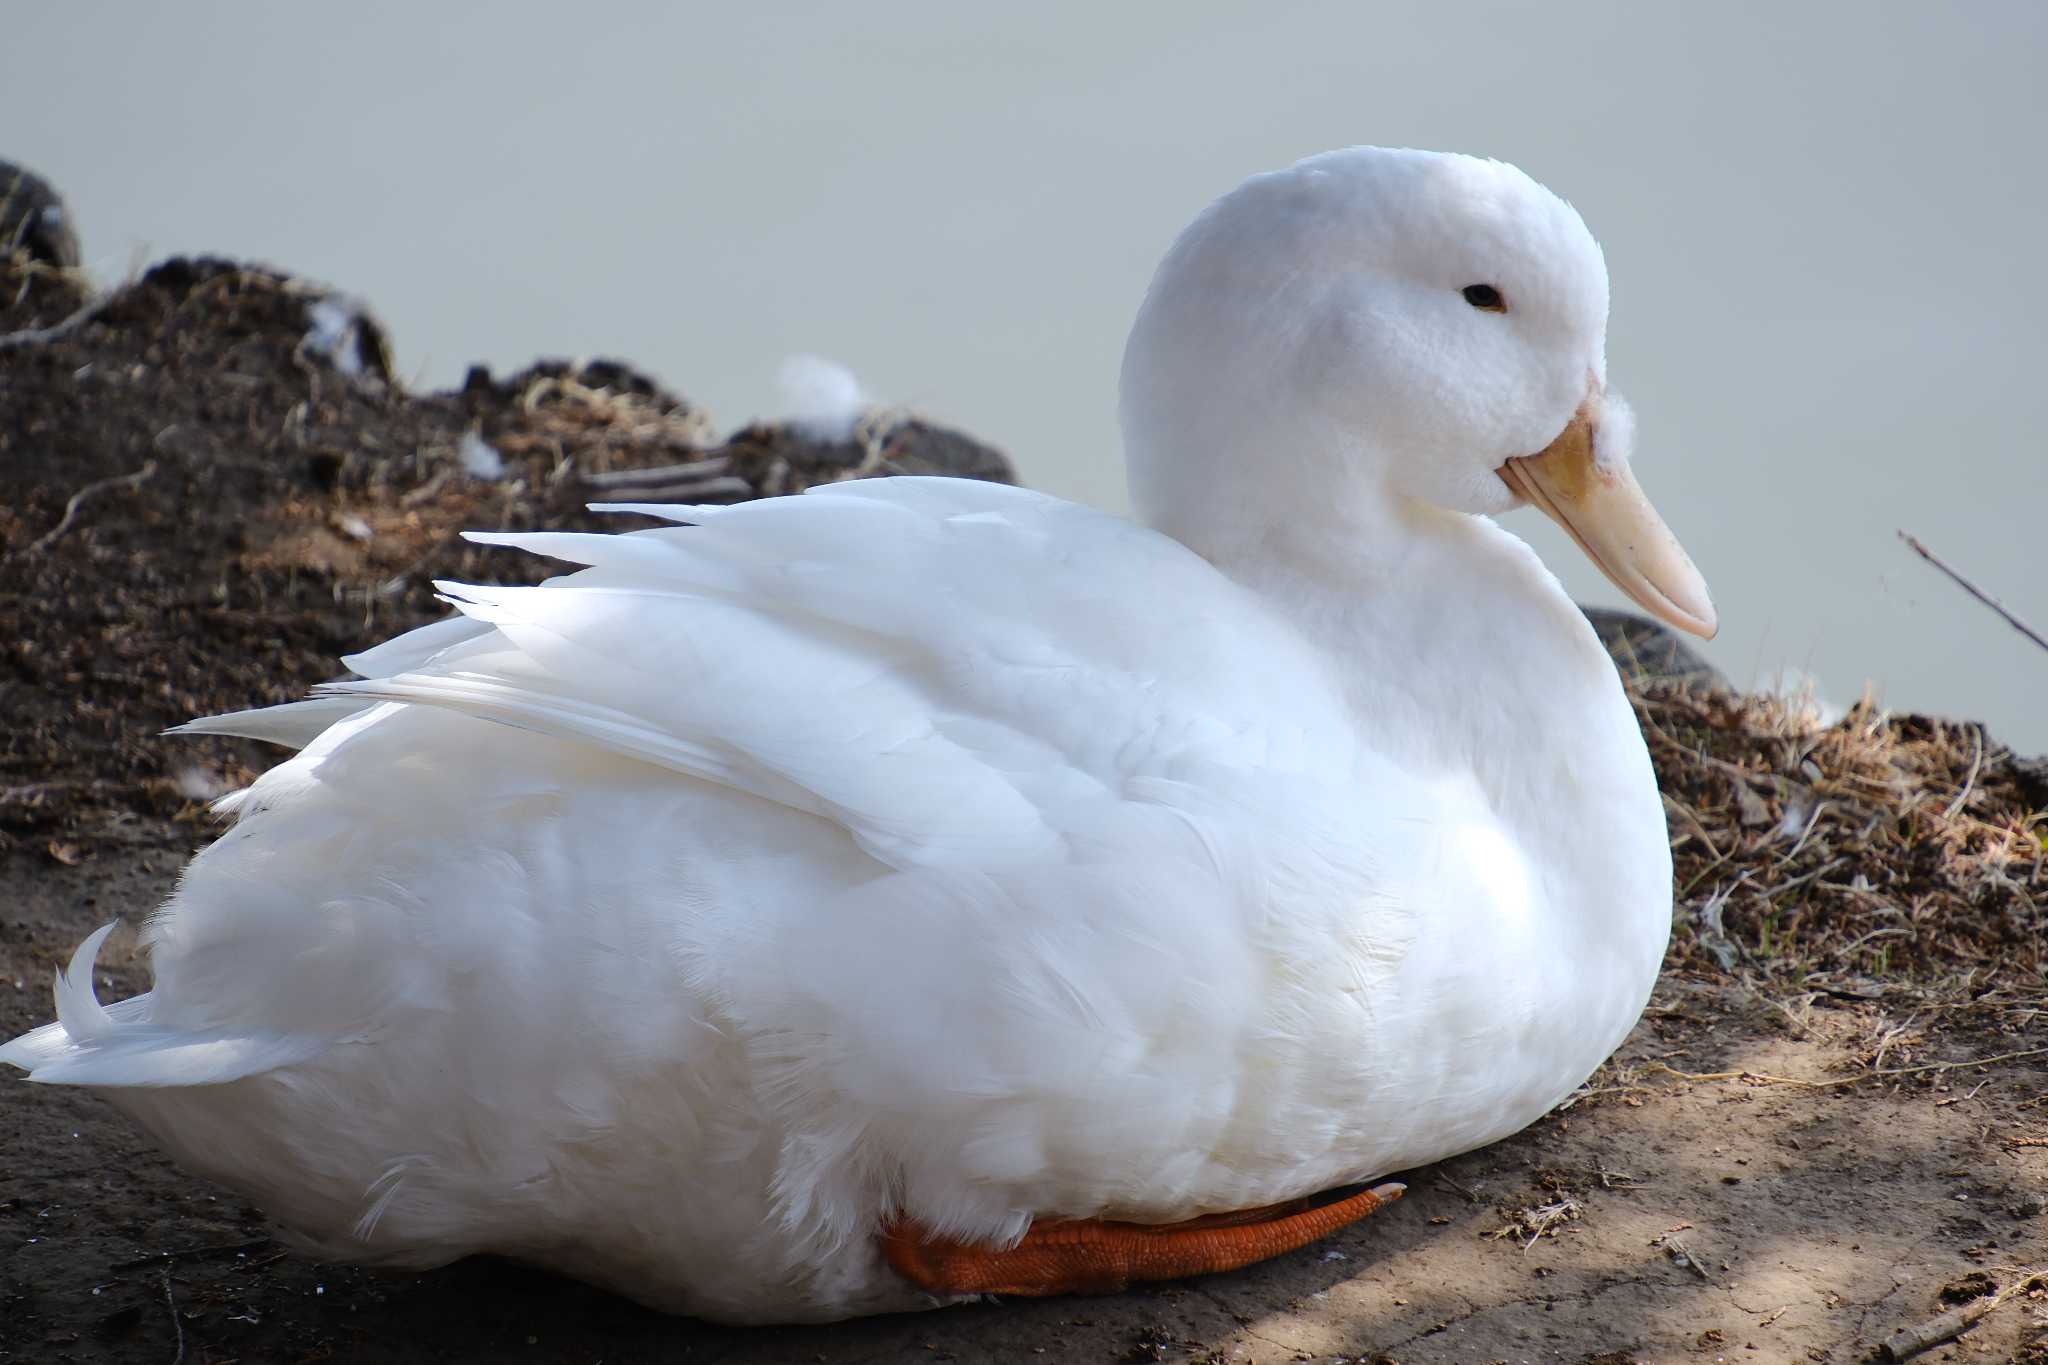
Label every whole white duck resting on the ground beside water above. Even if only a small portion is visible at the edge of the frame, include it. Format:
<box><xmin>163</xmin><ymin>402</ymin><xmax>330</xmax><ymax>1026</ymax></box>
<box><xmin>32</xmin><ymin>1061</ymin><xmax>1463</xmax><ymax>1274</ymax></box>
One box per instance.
<box><xmin>0</xmin><ymin>147</ymin><xmax>1714</xmax><ymax>1322</ymax></box>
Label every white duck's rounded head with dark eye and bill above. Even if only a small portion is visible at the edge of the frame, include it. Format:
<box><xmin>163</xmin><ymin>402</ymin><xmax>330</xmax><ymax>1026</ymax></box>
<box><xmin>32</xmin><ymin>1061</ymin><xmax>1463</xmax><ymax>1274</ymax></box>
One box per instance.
<box><xmin>1122</xmin><ymin>147</ymin><xmax>1714</xmax><ymax>636</ymax></box>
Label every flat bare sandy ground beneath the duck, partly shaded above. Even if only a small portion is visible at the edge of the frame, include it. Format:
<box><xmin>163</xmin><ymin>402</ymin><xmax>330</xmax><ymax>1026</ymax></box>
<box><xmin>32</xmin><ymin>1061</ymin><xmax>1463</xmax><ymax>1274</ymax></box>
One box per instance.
<box><xmin>0</xmin><ymin>847</ymin><xmax>2048</xmax><ymax>1365</ymax></box>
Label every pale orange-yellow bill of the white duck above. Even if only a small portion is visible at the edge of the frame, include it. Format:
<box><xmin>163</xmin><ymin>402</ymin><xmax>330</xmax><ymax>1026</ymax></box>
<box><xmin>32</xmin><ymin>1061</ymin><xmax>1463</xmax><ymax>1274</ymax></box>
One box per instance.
<box><xmin>1499</xmin><ymin>403</ymin><xmax>1720</xmax><ymax>641</ymax></box>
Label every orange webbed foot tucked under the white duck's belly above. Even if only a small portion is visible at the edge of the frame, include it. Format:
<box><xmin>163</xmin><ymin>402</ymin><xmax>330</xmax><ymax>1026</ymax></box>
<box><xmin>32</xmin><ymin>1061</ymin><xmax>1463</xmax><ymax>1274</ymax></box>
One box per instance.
<box><xmin>881</xmin><ymin>1183</ymin><xmax>1407</xmax><ymax>1297</ymax></box>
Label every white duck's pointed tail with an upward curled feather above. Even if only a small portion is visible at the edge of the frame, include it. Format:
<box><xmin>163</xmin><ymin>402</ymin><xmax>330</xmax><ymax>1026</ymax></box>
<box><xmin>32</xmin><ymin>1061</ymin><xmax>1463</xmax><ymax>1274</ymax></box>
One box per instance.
<box><xmin>0</xmin><ymin>925</ymin><xmax>332</xmax><ymax>1087</ymax></box>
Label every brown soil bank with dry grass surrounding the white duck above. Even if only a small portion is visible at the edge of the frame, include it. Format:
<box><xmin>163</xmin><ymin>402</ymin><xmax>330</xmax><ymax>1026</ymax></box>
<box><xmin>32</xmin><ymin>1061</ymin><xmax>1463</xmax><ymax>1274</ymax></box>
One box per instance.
<box><xmin>0</xmin><ymin>248</ymin><xmax>2048</xmax><ymax>1365</ymax></box>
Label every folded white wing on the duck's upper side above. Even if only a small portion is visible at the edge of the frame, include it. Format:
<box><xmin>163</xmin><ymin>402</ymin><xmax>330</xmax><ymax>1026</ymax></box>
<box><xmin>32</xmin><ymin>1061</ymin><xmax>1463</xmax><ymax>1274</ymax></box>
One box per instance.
<box><xmin>224</xmin><ymin>479</ymin><xmax>1339</xmax><ymax>868</ymax></box>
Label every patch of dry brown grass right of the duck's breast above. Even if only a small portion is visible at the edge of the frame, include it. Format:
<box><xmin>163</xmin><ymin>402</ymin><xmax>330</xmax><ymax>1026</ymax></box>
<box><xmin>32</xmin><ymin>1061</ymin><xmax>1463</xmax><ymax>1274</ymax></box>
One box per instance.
<box><xmin>1634</xmin><ymin>681</ymin><xmax>2048</xmax><ymax>1019</ymax></box>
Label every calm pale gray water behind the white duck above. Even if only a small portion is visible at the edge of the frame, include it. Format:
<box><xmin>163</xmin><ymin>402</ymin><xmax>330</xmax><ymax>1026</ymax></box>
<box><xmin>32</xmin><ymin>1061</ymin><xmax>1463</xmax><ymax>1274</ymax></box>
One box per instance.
<box><xmin>0</xmin><ymin>0</ymin><xmax>2048</xmax><ymax>751</ymax></box>
